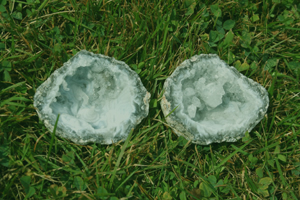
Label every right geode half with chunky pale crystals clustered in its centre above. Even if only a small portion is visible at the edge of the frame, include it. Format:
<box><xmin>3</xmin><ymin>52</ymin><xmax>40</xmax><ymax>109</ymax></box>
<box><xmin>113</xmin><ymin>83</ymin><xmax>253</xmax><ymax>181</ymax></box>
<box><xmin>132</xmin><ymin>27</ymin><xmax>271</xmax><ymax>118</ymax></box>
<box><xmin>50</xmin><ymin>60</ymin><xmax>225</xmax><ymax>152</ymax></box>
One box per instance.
<box><xmin>161</xmin><ymin>54</ymin><xmax>269</xmax><ymax>145</ymax></box>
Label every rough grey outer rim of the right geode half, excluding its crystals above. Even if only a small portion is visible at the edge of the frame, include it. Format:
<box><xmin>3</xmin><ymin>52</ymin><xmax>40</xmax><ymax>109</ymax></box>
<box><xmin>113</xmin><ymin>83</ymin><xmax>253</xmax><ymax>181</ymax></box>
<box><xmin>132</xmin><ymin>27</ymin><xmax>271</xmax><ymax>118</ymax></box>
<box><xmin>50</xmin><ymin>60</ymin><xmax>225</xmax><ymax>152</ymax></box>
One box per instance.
<box><xmin>161</xmin><ymin>54</ymin><xmax>269</xmax><ymax>145</ymax></box>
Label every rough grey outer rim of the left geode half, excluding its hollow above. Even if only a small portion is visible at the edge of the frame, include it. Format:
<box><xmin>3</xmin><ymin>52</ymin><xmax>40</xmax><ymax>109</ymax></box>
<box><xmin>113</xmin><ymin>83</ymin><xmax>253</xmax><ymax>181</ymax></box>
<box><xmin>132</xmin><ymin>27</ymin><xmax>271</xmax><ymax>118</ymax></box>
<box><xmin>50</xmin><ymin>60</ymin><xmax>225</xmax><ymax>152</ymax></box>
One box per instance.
<box><xmin>34</xmin><ymin>50</ymin><xmax>151</xmax><ymax>145</ymax></box>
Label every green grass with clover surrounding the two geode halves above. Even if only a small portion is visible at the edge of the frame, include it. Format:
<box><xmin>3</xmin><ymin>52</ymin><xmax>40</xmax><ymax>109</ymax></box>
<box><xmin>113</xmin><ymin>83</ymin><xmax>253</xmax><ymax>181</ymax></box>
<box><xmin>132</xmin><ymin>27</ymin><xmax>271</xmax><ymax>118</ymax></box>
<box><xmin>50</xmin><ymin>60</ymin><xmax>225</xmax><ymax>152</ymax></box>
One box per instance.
<box><xmin>0</xmin><ymin>0</ymin><xmax>300</xmax><ymax>200</ymax></box>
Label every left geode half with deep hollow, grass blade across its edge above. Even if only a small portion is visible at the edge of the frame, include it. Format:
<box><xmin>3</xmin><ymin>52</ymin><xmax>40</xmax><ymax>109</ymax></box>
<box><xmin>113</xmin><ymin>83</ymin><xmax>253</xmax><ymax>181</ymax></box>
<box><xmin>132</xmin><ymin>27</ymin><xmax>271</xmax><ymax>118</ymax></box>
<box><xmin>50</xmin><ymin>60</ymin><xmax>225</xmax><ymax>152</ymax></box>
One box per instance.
<box><xmin>34</xmin><ymin>50</ymin><xmax>150</xmax><ymax>144</ymax></box>
